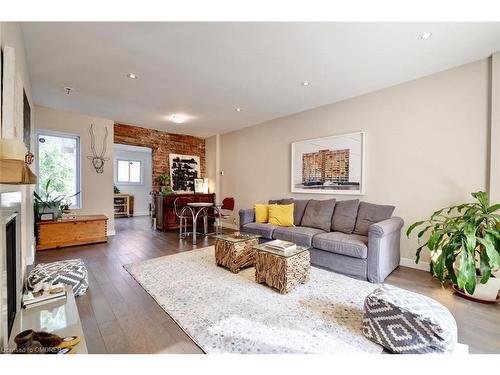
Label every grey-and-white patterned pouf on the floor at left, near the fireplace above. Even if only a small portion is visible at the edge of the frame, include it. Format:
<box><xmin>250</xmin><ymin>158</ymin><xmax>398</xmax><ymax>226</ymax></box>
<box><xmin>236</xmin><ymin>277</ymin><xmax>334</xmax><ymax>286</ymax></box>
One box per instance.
<box><xmin>26</xmin><ymin>259</ymin><xmax>89</xmax><ymax>296</ymax></box>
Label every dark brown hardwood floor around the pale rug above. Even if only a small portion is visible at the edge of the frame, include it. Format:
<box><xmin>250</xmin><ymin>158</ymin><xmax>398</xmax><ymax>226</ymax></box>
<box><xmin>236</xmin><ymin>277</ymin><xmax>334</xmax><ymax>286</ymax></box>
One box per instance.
<box><xmin>36</xmin><ymin>217</ymin><xmax>500</xmax><ymax>353</ymax></box>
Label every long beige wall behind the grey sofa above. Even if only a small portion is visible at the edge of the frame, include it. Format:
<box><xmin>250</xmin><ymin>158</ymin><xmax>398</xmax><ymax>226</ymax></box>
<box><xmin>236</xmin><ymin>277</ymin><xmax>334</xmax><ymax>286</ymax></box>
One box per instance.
<box><xmin>219</xmin><ymin>59</ymin><xmax>492</xmax><ymax>262</ymax></box>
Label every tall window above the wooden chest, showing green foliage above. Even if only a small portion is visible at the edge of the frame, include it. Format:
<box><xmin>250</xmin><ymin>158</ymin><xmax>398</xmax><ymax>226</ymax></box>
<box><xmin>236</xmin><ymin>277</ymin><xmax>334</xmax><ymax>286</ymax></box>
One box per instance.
<box><xmin>37</xmin><ymin>130</ymin><xmax>81</xmax><ymax>208</ymax></box>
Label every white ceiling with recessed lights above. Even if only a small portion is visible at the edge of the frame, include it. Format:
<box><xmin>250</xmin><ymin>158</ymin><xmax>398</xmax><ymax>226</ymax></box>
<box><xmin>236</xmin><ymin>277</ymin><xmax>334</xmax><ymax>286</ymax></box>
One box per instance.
<box><xmin>23</xmin><ymin>22</ymin><xmax>500</xmax><ymax>137</ymax></box>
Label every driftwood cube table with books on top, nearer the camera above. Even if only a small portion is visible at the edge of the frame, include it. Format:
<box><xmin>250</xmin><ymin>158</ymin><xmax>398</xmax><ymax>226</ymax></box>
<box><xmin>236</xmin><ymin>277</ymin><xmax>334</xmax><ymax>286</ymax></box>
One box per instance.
<box><xmin>254</xmin><ymin>243</ymin><xmax>311</xmax><ymax>294</ymax></box>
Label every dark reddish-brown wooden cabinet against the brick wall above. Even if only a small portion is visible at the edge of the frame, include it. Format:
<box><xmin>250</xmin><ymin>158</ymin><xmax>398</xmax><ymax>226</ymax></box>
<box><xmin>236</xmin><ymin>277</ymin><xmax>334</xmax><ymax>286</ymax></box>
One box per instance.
<box><xmin>154</xmin><ymin>193</ymin><xmax>215</xmax><ymax>232</ymax></box>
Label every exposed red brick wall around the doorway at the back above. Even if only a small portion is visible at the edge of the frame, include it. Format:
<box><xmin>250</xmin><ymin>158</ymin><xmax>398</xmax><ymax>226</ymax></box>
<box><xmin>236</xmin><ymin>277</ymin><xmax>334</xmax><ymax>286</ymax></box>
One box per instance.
<box><xmin>114</xmin><ymin>124</ymin><xmax>206</xmax><ymax>191</ymax></box>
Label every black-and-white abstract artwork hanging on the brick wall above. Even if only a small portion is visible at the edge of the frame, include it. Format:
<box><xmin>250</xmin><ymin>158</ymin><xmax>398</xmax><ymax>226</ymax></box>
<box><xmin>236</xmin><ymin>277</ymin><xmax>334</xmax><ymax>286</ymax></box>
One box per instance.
<box><xmin>169</xmin><ymin>154</ymin><xmax>200</xmax><ymax>193</ymax></box>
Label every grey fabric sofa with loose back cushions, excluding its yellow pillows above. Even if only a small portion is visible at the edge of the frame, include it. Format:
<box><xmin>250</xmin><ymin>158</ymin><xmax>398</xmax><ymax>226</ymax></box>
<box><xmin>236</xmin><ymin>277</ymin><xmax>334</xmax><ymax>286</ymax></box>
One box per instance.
<box><xmin>239</xmin><ymin>198</ymin><xmax>403</xmax><ymax>283</ymax></box>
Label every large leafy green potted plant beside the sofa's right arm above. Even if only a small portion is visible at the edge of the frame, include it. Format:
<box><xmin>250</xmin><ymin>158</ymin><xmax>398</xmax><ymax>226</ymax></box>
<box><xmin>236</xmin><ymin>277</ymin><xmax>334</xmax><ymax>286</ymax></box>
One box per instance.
<box><xmin>406</xmin><ymin>191</ymin><xmax>500</xmax><ymax>302</ymax></box>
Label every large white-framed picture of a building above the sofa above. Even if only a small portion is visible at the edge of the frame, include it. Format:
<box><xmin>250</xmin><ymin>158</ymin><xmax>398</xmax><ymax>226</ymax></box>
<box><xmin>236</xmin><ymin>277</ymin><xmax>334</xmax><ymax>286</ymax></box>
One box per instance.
<box><xmin>291</xmin><ymin>132</ymin><xmax>365</xmax><ymax>195</ymax></box>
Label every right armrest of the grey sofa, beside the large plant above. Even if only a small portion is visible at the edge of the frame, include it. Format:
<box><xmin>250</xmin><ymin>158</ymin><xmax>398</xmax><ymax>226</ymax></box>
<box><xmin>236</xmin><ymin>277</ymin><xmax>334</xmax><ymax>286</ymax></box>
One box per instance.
<box><xmin>367</xmin><ymin>217</ymin><xmax>404</xmax><ymax>283</ymax></box>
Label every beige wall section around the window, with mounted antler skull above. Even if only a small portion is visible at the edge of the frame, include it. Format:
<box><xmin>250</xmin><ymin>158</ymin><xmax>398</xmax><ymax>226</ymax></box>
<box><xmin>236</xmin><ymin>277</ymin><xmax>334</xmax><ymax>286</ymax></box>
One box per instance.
<box><xmin>35</xmin><ymin>106</ymin><xmax>115</xmax><ymax>235</ymax></box>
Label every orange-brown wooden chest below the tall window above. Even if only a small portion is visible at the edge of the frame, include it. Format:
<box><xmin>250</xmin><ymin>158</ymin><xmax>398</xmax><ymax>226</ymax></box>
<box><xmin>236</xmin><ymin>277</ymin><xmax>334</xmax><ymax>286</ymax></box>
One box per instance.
<box><xmin>36</xmin><ymin>215</ymin><xmax>108</xmax><ymax>250</ymax></box>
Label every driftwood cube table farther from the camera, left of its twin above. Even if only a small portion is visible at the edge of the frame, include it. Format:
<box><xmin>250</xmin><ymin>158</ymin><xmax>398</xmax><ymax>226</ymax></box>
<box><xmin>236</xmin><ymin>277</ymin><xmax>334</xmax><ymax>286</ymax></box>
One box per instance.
<box><xmin>214</xmin><ymin>233</ymin><xmax>260</xmax><ymax>273</ymax></box>
